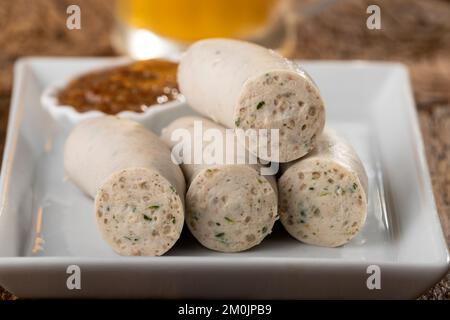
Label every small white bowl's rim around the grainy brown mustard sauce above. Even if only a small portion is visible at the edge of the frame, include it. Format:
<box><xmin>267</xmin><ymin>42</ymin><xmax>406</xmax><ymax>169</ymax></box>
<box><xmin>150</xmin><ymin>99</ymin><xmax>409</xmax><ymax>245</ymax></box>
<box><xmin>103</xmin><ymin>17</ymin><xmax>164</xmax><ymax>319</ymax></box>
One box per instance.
<box><xmin>41</xmin><ymin>59</ymin><xmax>185</xmax><ymax>128</ymax></box>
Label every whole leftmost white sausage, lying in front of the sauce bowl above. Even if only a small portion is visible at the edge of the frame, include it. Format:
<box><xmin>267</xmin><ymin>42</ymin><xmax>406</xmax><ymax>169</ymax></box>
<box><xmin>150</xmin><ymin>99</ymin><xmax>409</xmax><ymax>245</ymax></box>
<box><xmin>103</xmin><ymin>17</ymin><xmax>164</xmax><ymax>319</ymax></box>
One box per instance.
<box><xmin>64</xmin><ymin>116</ymin><xmax>185</xmax><ymax>255</ymax></box>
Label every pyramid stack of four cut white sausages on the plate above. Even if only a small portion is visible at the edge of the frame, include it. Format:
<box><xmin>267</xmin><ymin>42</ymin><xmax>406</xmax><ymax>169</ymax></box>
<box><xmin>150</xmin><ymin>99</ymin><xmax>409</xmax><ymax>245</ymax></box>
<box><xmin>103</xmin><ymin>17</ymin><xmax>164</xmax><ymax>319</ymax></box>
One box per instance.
<box><xmin>65</xmin><ymin>39</ymin><xmax>368</xmax><ymax>255</ymax></box>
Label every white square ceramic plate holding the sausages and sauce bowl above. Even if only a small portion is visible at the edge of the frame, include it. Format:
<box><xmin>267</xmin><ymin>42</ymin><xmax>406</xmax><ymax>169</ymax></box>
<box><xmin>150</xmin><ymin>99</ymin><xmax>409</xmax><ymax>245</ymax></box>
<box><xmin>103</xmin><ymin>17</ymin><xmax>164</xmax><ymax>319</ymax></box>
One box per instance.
<box><xmin>0</xmin><ymin>58</ymin><xmax>449</xmax><ymax>299</ymax></box>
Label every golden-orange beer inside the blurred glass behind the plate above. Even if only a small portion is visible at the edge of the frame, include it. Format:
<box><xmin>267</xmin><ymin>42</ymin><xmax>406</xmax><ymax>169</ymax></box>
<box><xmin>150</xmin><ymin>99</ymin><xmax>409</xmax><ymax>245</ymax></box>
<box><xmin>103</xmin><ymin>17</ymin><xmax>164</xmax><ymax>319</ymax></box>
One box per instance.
<box><xmin>117</xmin><ymin>0</ymin><xmax>278</xmax><ymax>56</ymax></box>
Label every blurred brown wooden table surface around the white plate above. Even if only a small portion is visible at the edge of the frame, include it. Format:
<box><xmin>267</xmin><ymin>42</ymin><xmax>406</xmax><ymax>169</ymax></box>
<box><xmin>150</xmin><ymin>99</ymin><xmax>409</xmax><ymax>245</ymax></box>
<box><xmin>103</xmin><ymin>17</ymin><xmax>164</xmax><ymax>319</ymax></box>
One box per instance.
<box><xmin>0</xmin><ymin>0</ymin><xmax>450</xmax><ymax>299</ymax></box>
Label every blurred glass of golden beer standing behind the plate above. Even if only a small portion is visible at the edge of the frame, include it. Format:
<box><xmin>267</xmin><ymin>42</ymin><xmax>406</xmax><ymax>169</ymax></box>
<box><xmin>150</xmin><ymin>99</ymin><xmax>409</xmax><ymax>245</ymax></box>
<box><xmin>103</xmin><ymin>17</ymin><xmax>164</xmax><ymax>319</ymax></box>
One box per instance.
<box><xmin>113</xmin><ymin>0</ymin><xmax>281</xmax><ymax>59</ymax></box>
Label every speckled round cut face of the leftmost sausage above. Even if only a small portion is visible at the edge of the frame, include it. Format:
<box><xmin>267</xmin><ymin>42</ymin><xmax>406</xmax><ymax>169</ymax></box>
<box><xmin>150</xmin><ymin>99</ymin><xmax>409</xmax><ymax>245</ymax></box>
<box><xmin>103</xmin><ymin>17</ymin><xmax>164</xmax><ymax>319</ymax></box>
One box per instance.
<box><xmin>95</xmin><ymin>168</ymin><xmax>184</xmax><ymax>256</ymax></box>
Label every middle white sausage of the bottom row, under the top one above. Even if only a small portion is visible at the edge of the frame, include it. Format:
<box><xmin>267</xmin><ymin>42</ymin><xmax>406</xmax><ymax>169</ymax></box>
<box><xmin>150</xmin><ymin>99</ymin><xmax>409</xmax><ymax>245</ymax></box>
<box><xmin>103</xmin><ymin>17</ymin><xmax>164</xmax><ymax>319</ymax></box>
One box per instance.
<box><xmin>163</xmin><ymin>117</ymin><xmax>278</xmax><ymax>252</ymax></box>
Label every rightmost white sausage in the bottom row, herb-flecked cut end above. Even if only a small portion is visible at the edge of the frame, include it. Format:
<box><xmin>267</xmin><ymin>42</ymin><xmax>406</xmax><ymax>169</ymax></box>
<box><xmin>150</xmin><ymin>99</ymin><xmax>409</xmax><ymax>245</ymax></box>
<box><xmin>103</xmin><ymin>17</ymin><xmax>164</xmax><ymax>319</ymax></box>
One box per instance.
<box><xmin>278</xmin><ymin>129</ymin><xmax>368</xmax><ymax>247</ymax></box>
